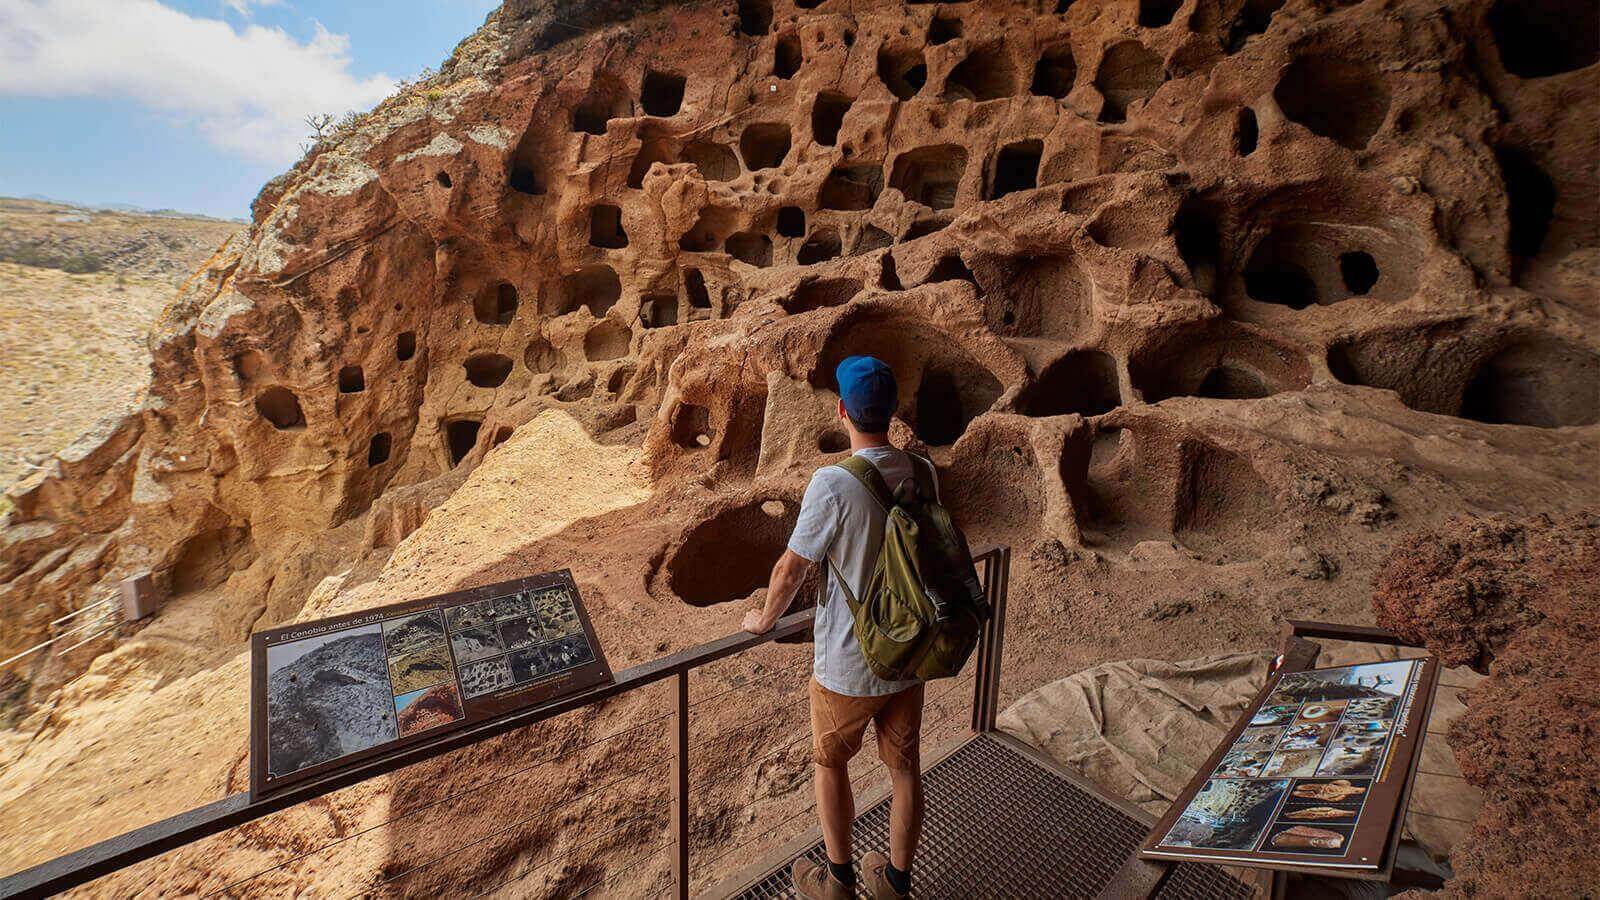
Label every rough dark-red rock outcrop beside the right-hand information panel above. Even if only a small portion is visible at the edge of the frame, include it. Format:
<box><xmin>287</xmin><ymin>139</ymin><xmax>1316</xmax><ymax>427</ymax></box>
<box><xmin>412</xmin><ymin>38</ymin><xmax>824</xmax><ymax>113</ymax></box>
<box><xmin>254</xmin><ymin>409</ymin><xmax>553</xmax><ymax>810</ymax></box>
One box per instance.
<box><xmin>1373</xmin><ymin>514</ymin><xmax>1600</xmax><ymax>897</ymax></box>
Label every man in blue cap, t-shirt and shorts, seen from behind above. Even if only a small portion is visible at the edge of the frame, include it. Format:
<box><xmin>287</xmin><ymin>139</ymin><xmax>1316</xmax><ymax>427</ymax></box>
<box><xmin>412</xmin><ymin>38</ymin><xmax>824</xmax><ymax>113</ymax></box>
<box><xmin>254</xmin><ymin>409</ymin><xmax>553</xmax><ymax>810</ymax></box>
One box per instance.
<box><xmin>744</xmin><ymin>356</ymin><xmax>933</xmax><ymax>900</ymax></box>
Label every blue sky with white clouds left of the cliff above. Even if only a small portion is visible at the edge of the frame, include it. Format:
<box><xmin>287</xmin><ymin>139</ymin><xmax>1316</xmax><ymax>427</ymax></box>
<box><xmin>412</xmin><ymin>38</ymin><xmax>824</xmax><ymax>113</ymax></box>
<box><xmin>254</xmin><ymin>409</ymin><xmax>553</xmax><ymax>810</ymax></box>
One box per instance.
<box><xmin>0</xmin><ymin>0</ymin><xmax>499</xmax><ymax>218</ymax></box>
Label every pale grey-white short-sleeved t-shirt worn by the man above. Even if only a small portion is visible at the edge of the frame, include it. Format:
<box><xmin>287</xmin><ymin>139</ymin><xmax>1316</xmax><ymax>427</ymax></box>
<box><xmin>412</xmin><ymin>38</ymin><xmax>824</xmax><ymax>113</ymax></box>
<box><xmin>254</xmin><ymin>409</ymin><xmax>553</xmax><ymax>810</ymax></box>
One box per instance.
<box><xmin>789</xmin><ymin>447</ymin><xmax>938</xmax><ymax>697</ymax></box>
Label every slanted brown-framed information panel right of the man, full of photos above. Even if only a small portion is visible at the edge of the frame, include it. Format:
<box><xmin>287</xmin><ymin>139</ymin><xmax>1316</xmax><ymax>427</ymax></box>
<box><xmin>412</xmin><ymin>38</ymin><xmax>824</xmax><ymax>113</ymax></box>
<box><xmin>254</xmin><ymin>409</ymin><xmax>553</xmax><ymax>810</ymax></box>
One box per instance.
<box><xmin>1142</xmin><ymin>658</ymin><xmax>1438</xmax><ymax>874</ymax></box>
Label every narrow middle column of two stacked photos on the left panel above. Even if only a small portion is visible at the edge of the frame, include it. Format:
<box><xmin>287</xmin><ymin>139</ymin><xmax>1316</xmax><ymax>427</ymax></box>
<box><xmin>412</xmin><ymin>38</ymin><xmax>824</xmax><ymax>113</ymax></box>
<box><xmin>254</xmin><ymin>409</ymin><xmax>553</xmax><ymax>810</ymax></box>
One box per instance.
<box><xmin>382</xmin><ymin>610</ymin><xmax>464</xmax><ymax>737</ymax></box>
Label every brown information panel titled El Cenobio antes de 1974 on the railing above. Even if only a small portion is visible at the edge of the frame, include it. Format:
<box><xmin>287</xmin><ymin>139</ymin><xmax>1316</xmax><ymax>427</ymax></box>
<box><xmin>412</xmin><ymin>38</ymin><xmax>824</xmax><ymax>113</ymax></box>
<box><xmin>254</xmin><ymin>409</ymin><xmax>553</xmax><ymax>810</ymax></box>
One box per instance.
<box><xmin>250</xmin><ymin>570</ymin><xmax>611</xmax><ymax>798</ymax></box>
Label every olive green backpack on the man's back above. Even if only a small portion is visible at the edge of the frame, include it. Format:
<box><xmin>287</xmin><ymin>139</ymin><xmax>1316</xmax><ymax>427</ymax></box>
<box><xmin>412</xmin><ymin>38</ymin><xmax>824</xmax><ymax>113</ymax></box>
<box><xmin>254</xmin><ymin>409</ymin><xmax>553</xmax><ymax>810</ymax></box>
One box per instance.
<box><xmin>824</xmin><ymin>455</ymin><xmax>989</xmax><ymax>681</ymax></box>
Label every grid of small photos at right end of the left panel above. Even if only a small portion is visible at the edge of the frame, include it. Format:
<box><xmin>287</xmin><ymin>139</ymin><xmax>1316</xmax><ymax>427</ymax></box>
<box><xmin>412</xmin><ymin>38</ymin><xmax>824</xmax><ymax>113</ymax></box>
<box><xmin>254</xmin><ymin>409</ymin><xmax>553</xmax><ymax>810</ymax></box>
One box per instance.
<box><xmin>445</xmin><ymin>585</ymin><xmax>595</xmax><ymax>698</ymax></box>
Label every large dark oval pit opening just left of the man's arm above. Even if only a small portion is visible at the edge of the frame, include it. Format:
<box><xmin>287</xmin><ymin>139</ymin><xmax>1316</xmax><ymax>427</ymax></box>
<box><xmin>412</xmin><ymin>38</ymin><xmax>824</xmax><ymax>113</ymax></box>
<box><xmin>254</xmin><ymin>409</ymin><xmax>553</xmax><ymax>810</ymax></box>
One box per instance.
<box><xmin>666</xmin><ymin>500</ymin><xmax>800</xmax><ymax>607</ymax></box>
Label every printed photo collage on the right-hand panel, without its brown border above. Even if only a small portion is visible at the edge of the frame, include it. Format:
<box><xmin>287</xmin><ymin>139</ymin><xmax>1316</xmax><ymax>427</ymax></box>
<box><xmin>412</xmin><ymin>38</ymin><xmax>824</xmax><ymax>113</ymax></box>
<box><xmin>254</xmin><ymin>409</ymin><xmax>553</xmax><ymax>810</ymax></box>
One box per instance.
<box><xmin>1162</xmin><ymin>660</ymin><xmax>1416</xmax><ymax>857</ymax></box>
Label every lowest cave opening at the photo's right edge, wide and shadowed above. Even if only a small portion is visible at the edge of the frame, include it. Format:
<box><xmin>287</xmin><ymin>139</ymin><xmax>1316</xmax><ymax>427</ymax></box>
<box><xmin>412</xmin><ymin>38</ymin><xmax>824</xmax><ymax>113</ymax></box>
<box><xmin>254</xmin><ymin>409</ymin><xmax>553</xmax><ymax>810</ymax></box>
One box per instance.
<box><xmin>1461</xmin><ymin>336</ymin><xmax>1600</xmax><ymax>428</ymax></box>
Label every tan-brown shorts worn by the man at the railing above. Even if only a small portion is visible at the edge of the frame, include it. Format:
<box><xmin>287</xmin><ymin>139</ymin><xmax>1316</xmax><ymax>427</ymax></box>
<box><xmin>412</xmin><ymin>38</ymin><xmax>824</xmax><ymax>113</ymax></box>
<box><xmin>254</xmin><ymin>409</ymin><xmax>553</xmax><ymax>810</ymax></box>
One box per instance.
<box><xmin>811</xmin><ymin>677</ymin><xmax>923</xmax><ymax>770</ymax></box>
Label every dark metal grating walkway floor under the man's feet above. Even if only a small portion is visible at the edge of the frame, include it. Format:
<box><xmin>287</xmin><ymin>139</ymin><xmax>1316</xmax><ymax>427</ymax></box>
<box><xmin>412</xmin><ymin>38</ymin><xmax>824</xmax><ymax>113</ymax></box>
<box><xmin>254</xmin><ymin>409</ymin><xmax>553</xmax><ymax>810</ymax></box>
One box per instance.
<box><xmin>723</xmin><ymin>735</ymin><xmax>1251</xmax><ymax>900</ymax></box>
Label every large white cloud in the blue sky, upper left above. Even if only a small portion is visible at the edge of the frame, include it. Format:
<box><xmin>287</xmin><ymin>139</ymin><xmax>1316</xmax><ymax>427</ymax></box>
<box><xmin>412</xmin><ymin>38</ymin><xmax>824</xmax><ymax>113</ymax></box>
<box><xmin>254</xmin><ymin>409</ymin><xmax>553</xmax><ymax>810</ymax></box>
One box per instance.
<box><xmin>0</xmin><ymin>0</ymin><xmax>394</xmax><ymax>165</ymax></box>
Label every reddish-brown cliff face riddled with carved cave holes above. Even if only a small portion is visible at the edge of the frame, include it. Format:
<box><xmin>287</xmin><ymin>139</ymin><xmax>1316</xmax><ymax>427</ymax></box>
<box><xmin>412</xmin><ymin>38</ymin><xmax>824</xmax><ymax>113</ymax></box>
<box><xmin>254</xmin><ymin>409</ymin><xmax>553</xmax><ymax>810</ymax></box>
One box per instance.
<box><xmin>0</xmin><ymin>0</ymin><xmax>1600</xmax><ymax>878</ymax></box>
